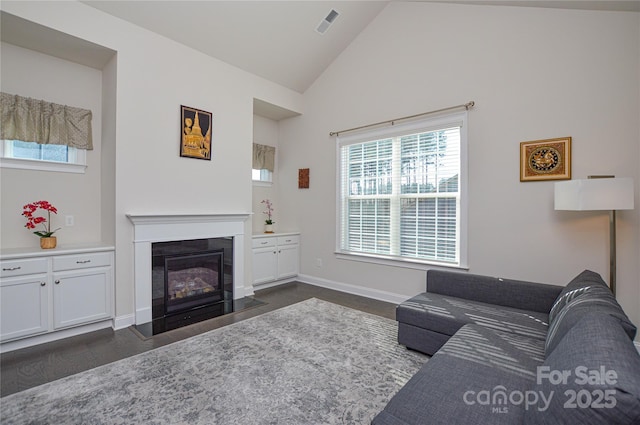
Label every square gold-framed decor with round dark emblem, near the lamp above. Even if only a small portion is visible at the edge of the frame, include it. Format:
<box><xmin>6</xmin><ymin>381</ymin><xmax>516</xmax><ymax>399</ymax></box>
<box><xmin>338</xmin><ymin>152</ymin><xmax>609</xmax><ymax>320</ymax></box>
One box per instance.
<box><xmin>520</xmin><ymin>137</ymin><xmax>571</xmax><ymax>182</ymax></box>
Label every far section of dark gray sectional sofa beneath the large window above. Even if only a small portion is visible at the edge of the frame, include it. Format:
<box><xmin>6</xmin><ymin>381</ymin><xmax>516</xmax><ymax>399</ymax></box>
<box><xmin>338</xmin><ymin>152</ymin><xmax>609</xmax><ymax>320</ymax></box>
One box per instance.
<box><xmin>396</xmin><ymin>270</ymin><xmax>562</xmax><ymax>355</ymax></box>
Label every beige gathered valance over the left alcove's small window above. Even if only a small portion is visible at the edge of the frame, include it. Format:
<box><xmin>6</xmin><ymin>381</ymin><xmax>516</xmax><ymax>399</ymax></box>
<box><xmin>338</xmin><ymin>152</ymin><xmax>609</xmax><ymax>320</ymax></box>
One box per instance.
<box><xmin>0</xmin><ymin>93</ymin><xmax>93</xmax><ymax>150</ymax></box>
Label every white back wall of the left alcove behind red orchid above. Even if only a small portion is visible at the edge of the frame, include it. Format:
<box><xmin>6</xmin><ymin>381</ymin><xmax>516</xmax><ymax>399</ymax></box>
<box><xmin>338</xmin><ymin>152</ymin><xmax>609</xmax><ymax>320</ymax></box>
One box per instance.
<box><xmin>0</xmin><ymin>43</ymin><xmax>102</xmax><ymax>247</ymax></box>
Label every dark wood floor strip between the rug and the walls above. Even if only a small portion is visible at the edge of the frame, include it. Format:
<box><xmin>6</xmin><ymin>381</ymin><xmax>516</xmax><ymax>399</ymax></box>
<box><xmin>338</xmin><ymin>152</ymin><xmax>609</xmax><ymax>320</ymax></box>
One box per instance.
<box><xmin>0</xmin><ymin>282</ymin><xmax>396</xmax><ymax>397</ymax></box>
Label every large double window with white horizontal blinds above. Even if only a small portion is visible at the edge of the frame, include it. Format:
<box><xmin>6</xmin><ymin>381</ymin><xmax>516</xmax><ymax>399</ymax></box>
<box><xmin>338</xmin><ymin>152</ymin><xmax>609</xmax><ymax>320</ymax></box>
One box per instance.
<box><xmin>338</xmin><ymin>112</ymin><xmax>467</xmax><ymax>267</ymax></box>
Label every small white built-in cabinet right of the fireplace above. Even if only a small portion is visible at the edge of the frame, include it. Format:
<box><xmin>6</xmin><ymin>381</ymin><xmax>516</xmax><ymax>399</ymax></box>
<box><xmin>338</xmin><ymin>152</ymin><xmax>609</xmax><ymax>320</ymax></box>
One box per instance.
<box><xmin>253</xmin><ymin>233</ymin><xmax>300</xmax><ymax>286</ymax></box>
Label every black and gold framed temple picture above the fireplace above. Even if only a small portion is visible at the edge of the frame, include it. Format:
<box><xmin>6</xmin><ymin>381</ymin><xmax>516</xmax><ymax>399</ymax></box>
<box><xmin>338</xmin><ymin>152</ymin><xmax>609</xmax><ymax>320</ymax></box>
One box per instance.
<box><xmin>180</xmin><ymin>106</ymin><xmax>213</xmax><ymax>161</ymax></box>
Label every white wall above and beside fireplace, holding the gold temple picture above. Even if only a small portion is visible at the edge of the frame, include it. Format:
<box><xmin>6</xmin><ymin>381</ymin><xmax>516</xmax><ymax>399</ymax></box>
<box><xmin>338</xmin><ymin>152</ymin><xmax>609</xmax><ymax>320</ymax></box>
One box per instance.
<box><xmin>2</xmin><ymin>1</ymin><xmax>302</xmax><ymax>320</ymax></box>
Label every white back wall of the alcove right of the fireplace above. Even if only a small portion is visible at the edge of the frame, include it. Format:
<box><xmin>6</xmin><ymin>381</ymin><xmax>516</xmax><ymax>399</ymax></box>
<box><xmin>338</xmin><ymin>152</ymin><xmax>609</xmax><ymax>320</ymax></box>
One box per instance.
<box><xmin>252</xmin><ymin>115</ymin><xmax>283</xmax><ymax>234</ymax></box>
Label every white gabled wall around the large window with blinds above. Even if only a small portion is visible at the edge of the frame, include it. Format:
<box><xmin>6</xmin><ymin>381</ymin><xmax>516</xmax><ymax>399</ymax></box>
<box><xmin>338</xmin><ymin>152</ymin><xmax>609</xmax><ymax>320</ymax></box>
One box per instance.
<box><xmin>280</xmin><ymin>2</ymin><xmax>640</xmax><ymax>323</ymax></box>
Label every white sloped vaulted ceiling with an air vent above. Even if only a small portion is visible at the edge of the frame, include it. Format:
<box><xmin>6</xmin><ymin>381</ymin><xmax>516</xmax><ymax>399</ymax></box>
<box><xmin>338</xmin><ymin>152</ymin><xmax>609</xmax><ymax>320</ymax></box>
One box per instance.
<box><xmin>84</xmin><ymin>0</ymin><xmax>640</xmax><ymax>93</ymax></box>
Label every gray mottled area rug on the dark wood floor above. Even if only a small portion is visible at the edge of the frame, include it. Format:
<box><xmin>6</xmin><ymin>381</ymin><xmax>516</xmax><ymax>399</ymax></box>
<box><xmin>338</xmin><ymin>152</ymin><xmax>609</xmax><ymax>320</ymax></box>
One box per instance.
<box><xmin>0</xmin><ymin>299</ymin><xmax>427</xmax><ymax>425</ymax></box>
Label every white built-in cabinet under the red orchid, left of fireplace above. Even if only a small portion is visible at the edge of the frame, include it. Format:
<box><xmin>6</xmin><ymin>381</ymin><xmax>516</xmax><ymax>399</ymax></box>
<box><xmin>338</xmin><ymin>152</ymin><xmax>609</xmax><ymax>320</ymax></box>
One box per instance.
<box><xmin>0</xmin><ymin>246</ymin><xmax>114</xmax><ymax>351</ymax></box>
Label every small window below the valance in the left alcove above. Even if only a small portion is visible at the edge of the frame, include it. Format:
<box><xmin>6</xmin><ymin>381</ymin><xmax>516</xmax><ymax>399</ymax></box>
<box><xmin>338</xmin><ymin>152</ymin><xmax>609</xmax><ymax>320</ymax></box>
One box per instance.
<box><xmin>0</xmin><ymin>140</ymin><xmax>86</xmax><ymax>173</ymax></box>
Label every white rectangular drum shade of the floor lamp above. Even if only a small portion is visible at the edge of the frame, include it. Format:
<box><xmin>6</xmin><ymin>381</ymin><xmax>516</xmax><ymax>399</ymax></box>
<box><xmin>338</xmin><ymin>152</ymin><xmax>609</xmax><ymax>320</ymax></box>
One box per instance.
<box><xmin>555</xmin><ymin>178</ymin><xmax>634</xmax><ymax>211</ymax></box>
